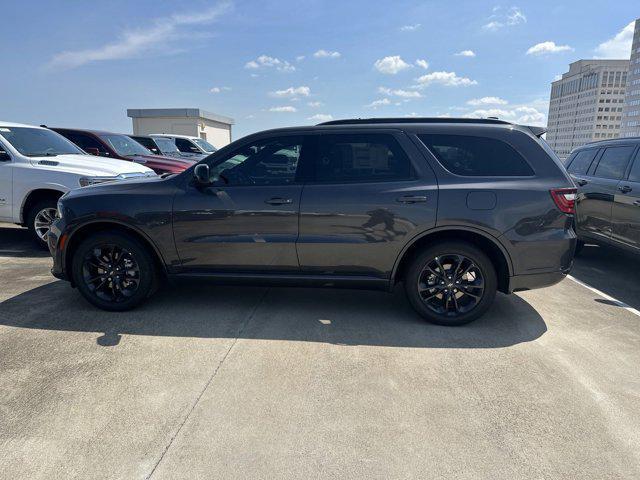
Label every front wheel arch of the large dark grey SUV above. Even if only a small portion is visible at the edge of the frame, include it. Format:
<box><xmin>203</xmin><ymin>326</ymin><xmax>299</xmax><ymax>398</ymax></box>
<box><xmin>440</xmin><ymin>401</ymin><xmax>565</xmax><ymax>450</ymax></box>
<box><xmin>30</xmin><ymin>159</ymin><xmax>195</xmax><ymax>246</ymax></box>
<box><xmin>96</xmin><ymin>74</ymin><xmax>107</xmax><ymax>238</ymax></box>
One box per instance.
<box><xmin>64</xmin><ymin>219</ymin><xmax>167</xmax><ymax>281</ymax></box>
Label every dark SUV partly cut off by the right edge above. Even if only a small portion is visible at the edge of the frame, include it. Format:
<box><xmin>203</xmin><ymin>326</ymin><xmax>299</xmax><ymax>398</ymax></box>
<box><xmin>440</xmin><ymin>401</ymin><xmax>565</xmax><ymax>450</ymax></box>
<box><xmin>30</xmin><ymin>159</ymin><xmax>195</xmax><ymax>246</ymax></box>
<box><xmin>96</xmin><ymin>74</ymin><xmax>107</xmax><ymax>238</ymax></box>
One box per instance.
<box><xmin>566</xmin><ymin>137</ymin><xmax>640</xmax><ymax>253</ymax></box>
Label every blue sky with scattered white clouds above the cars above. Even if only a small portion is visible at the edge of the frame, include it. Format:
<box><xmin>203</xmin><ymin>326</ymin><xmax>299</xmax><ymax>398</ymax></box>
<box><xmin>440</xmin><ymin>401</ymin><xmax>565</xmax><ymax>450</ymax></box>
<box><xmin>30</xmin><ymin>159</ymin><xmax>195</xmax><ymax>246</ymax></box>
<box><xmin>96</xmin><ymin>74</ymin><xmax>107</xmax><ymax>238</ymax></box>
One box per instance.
<box><xmin>0</xmin><ymin>0</ymin><xmax>640</xmax><ymax>138</ymax></box>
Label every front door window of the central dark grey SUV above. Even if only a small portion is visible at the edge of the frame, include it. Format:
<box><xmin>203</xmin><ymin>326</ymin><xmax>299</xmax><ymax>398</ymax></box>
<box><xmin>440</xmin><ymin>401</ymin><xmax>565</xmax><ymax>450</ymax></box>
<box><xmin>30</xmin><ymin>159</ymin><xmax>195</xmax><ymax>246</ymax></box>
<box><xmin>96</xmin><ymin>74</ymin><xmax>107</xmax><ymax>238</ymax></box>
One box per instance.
<box><xmin>206</xmin><ymin>137</ymin><xmax>303</xmax><ymax>185</ymax></box>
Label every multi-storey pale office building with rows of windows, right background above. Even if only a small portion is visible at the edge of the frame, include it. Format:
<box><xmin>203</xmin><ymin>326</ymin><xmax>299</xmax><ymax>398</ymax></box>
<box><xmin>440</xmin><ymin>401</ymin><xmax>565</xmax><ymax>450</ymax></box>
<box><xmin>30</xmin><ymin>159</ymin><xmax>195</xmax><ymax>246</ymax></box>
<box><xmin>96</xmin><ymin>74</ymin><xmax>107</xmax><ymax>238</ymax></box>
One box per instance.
<box><xmin>546</xmin><ymin>59</ymin><xmax>629</xmax><ymax>158</ymax></box>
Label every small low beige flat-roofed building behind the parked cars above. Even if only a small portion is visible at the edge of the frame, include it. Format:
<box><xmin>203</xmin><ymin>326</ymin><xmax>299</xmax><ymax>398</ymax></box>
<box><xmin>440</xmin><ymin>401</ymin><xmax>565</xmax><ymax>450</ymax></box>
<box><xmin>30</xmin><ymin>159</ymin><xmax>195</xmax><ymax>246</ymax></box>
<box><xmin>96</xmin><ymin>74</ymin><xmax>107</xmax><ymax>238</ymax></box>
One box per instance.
<box><xmin>127</xmin><ymin>108</ymin><xmax>235</xmax><ymax>148</ymax></box>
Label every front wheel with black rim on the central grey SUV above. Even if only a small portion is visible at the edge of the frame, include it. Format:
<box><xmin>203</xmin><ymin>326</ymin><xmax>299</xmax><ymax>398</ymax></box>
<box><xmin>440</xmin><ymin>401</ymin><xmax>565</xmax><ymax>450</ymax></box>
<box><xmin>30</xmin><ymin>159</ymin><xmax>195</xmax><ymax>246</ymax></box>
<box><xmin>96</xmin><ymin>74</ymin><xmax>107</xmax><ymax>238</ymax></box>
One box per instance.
<box><xmin>71</xmin><ymin>232</ymin><xmax>158</xmax><ymax>312</ymax></box>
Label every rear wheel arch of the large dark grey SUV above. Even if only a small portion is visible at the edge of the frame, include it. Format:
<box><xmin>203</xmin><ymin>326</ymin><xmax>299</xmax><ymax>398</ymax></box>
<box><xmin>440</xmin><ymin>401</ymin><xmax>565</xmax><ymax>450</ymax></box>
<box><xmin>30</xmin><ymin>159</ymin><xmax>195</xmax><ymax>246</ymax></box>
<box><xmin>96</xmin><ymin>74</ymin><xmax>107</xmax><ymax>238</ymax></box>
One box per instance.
<box><xmin>391</xmin><ymin>226</ymin><xmax>513</xmax><ymax>293</ymax></box>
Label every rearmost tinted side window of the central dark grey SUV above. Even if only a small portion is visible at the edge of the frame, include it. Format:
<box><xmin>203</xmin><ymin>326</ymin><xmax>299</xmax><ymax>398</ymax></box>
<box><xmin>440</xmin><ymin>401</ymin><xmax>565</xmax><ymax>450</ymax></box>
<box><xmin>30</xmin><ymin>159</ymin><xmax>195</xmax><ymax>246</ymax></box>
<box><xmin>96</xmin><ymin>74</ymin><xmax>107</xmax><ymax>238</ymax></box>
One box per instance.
<box><xmin>418</xmin><ymin>135</ymin><xmax>534</xmax><ymax>177</ymax></box>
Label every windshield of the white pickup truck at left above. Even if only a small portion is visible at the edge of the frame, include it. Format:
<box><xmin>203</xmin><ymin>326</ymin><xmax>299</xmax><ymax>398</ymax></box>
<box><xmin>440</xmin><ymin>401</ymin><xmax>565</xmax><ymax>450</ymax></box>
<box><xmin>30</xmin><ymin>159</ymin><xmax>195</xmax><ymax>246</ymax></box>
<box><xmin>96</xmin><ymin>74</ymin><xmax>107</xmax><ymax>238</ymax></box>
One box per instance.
<box><xmin>0</xmin><ymin>127</ymin><xmax>84</xmax><ymax>157</ymax></box>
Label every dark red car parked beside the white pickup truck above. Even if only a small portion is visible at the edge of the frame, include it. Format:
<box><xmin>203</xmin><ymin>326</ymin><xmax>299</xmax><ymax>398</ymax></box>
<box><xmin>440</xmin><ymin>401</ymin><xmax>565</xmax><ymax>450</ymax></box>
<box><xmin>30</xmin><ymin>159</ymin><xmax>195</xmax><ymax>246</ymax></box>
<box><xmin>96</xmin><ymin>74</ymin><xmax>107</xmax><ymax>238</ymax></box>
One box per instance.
<box><xmin>51</xmin><ymin>128</ymin><xmax>195</xmax><ymax>174</ymax></box>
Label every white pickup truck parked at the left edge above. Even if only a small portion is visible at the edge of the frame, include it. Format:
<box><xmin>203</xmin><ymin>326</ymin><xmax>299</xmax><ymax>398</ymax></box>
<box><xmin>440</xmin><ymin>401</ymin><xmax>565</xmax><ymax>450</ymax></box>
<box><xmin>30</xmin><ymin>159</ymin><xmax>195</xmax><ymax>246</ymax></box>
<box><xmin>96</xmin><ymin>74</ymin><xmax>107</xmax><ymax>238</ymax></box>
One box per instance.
<box><xmin>0</xmin><ymin>121</ymin><xmax>155</xmax><ymax>247</ymax></box>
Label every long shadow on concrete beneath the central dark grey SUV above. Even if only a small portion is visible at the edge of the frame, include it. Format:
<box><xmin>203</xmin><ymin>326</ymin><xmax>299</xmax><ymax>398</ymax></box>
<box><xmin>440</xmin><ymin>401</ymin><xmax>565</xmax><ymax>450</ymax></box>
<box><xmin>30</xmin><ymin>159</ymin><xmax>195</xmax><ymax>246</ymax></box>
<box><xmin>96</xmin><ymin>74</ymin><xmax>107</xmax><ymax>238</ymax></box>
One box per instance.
<box><xmin>0</xmin><ymin>282</ymin><xmax>547</xmax><ymax>348</ymax></box>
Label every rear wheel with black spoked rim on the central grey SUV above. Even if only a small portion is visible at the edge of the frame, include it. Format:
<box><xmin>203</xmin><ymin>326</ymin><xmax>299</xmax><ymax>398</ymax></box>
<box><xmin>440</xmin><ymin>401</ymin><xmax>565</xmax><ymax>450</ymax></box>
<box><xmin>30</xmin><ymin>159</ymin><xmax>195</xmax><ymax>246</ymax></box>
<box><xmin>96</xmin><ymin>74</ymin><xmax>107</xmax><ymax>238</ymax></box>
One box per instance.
<box><xmin>404</xmin><ymin>241</ymin><xmax>498</xmax><ymax>326</ymax></box>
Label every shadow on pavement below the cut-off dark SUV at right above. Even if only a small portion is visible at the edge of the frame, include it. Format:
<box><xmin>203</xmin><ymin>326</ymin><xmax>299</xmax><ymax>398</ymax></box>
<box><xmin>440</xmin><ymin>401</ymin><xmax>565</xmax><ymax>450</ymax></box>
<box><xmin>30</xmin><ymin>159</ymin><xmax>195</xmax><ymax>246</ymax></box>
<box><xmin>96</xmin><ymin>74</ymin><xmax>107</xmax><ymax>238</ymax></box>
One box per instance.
<box><xmin>571</xmin><ymin>245</ymin><xmax>640</xmax><ymax>309</ymax></box>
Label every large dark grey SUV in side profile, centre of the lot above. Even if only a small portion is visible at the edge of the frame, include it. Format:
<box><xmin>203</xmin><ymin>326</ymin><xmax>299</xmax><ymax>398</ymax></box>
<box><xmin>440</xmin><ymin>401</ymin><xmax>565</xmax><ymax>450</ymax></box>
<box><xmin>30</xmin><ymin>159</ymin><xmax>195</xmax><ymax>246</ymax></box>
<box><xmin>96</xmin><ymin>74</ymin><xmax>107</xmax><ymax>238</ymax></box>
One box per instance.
<box><xmin>49</xmin><ymin>118</ymin><xmax>576</xmax><ymax>325</ymax></box>
